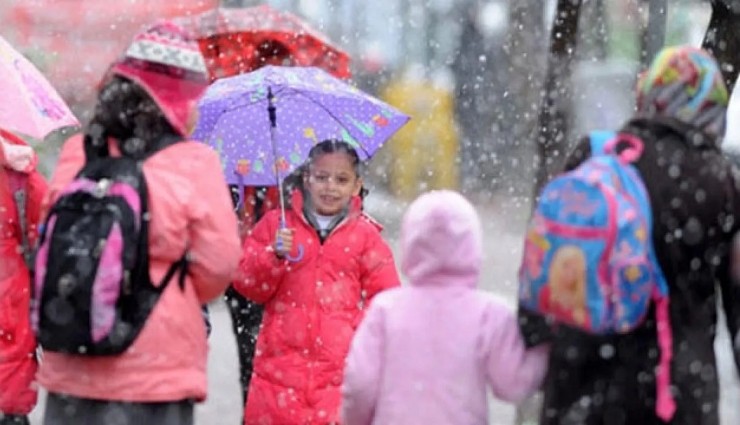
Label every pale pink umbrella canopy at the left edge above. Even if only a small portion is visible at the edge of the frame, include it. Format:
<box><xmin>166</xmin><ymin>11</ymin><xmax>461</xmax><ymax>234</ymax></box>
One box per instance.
<box><xmin>0</xmin><ymin>37</ymin><xmax>80</xmax><ymax>139</ymax></box>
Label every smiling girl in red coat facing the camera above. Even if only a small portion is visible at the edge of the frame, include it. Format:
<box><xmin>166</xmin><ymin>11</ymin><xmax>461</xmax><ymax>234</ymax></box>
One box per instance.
<box><xmin>235</xmin><ymin>140</ymin><xmax>399</xmax><ymax>424</ymax></box>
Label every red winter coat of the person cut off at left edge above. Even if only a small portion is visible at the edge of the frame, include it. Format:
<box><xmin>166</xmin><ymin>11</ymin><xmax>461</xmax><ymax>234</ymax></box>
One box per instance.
<box><xmin>0</xmin><ymin>130</ymin><xmax>46</xmax><ymax>415</ymax></box>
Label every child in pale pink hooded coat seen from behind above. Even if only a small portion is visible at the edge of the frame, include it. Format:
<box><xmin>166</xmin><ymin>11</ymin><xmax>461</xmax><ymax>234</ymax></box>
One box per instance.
<box><xmin>342</xmin><ymin>191</ymin><xmax>547</xmax><ymax>425</ymax></box>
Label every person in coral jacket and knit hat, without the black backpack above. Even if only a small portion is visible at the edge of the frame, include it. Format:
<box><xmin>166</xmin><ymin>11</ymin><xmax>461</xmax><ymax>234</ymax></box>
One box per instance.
<box><xmin>38</xmin><ymin>24</ymin><xmax>240</xmax><ymax>425</ymax></box>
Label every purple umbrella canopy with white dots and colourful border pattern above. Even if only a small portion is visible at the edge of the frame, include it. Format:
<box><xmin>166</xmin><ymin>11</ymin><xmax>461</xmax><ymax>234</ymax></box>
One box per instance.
<box><xmin>193</xmin><ymin>66</ymin><xmax>409</xmax><ymax>186</ymax></box>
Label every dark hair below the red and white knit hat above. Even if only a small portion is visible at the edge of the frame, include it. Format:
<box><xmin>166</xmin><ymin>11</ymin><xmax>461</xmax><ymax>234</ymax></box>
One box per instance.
<box><xmin>85</xmin><ymin>76</ymin><xmax>177</xmax><ymax>156</ymax></box>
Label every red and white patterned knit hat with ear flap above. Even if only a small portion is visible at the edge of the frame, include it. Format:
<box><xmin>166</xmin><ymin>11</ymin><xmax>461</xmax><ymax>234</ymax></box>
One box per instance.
<box><xmin>106</xmin><ymin>21</ymin><xmax>208</xmax><ymax>136</ymax></box>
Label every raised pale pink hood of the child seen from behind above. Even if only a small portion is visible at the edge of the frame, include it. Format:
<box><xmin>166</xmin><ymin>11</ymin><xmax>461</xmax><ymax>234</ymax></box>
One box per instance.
<box><xmin>401</xmin><ymin>190</ymin><xmax>483</xmax><ymax>287</ymax></box>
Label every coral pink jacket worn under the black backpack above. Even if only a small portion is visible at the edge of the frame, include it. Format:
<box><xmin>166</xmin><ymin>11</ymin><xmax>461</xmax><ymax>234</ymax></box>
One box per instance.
<box><xmin>38</xmin><ymin>136</ymin><xmax>241</xmax><ymax>402</ymax></box>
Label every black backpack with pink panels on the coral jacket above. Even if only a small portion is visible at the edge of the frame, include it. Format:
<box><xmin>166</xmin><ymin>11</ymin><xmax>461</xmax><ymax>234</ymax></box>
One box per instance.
<box><xmin>31</xmin><ymin>136</ymin><xmax>187</xmax><ymax>356</ymax></box>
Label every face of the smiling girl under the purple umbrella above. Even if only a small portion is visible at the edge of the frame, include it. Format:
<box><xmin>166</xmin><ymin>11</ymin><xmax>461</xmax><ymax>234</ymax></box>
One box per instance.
<box><xmin>304</xmin><ymin>152</ymin><xmax>362</xmax><ymax>215</ymax></box>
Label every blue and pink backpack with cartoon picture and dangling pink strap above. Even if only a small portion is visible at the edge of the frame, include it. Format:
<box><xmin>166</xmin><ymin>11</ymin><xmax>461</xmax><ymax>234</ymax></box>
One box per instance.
<box><xmin>519</xmin><ymin>132</ymin><xmax>675</xmax><ymax>417</ymax></box>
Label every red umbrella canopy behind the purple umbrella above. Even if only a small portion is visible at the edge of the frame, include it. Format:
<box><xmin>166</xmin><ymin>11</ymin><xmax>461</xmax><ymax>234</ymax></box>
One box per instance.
<box><xmin>174</xmin><ymin>5</ymin><xmax>351</xmax><ymax>80</ymax></box>
